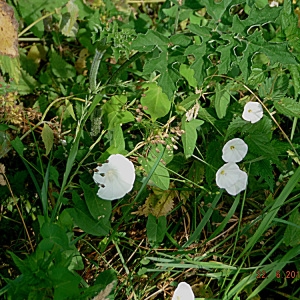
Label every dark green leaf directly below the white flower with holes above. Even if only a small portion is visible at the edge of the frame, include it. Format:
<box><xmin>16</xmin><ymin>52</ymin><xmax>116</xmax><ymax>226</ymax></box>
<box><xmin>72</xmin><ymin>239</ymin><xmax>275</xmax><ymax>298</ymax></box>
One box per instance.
<box><xmin>79</xmin><ymin>180</ymin><xmax>111</xmax><ymax>223</ymax></box>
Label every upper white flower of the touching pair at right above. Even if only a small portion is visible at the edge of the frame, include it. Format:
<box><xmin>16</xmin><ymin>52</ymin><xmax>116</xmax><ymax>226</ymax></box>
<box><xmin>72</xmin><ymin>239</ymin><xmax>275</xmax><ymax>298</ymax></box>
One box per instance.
<box><xmin>222</xmin><ymin>138</ymin><xmax>248</xmax><ymax>162</ymax></box>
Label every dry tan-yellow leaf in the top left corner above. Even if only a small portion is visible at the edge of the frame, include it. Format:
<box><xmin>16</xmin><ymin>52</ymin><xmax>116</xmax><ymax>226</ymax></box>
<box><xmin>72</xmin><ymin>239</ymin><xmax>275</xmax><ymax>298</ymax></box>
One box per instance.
<box><xmin>0</xmin><ymin>1</ymin><xmax>19</xmax><ymax>57</ymax></box>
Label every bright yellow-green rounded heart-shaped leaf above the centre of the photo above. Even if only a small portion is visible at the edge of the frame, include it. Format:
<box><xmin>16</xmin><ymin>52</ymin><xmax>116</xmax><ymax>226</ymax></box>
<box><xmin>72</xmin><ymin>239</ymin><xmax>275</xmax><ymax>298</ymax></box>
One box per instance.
<box><xmin>141</xmin><ymin>83</ymin><xmax>171</xmax><ymax>121</ymax></box>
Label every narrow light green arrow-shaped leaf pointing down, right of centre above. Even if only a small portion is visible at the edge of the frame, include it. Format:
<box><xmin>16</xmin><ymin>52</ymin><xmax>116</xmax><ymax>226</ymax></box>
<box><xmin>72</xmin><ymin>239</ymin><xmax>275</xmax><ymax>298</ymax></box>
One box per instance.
<box><xmin>181</xmin><ymin>117</ymin><xmax>204</xmax><ymax>158</ymax></box>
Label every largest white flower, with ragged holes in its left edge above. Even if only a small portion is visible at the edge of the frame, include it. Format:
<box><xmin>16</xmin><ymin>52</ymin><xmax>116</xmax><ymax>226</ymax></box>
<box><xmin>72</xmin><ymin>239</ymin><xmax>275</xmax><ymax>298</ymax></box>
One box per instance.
<box><xmin>93</xmin><ymin>154</ymin><xmax>135</xmax><ymax>200</ymax></box>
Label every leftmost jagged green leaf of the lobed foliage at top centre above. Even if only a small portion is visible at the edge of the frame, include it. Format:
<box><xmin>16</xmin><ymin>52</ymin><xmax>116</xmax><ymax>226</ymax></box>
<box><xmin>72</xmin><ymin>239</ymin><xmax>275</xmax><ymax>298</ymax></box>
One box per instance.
<box><xmin>131</xmin><ymin>30</ymin><xmax>169</xmax><ymax>52</ymax></box>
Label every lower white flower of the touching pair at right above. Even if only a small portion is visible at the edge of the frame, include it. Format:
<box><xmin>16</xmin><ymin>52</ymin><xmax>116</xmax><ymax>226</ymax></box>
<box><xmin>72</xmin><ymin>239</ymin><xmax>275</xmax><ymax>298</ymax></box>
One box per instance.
<box><xmin>216</xmin><ymin>162</ymin><xmax>248</xmax><ymax>196</ymax></box>
